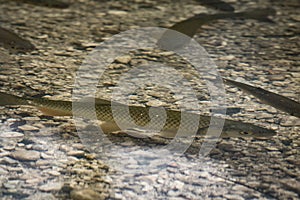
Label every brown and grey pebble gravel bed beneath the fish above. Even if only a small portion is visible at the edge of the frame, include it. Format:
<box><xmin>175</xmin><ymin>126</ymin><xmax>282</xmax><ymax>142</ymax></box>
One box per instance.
<box><xmin>0</xmin><ymin>0</ymin><xmax>300</xmax><ymax>199</ymax></box>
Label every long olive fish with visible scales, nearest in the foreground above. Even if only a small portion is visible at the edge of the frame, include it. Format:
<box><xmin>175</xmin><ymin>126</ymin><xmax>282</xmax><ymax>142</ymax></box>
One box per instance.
<box><xmin>0</xmin><ymin>92</ymin><xmax>276</xmax><ymax>138</ymax></box>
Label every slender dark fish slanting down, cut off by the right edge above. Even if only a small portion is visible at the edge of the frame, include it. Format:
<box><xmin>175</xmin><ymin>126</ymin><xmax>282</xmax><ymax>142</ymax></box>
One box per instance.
<box><xmin>223</xmin><ymin>78</ymin><xmax>300</xmax><ymax>118</ymax></box>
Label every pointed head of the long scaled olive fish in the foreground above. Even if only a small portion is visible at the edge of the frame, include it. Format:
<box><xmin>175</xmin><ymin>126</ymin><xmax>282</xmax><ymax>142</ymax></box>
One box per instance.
<box><xmin>221</xmin><ymin>120</ymin><xmax>276</xmax><ymax>137</ymax></box>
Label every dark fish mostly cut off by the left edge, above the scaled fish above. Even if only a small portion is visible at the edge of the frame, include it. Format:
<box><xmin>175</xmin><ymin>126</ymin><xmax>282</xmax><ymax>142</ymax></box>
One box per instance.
<box><xmin>0</xmin><ymin>27</ymin><xmax>36</xmax><ymax>53</ymax></box>
